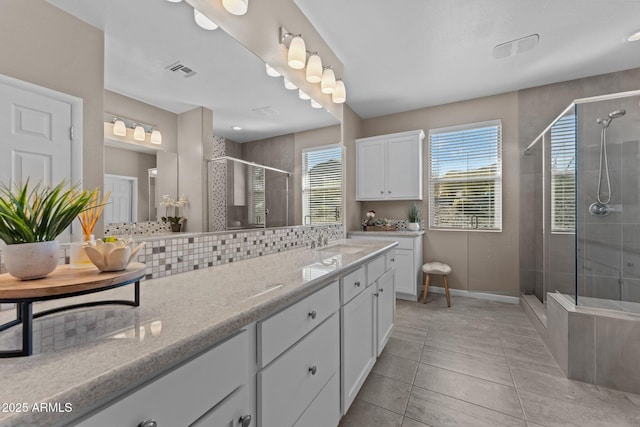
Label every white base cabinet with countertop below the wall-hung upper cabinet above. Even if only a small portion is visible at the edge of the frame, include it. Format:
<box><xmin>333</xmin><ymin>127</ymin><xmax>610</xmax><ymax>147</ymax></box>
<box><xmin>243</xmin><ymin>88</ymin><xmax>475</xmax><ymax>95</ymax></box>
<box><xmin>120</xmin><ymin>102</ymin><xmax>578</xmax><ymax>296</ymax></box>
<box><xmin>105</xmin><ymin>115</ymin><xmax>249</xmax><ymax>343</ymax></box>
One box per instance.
<box><xmin>349</xmin><ymin>231</ymin><xmax>424</xmax><ymax>301</ymax></box>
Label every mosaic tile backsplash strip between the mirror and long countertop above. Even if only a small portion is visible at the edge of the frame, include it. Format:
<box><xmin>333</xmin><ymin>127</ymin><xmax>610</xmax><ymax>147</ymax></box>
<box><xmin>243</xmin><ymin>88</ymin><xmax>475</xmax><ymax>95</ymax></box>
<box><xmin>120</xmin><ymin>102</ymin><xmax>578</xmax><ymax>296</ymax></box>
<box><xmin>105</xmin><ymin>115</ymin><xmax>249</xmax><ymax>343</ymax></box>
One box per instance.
<box><xmin>0</xmin><ymin>224</ymin><xmax>343</xmax><ymax>309</ymax></box>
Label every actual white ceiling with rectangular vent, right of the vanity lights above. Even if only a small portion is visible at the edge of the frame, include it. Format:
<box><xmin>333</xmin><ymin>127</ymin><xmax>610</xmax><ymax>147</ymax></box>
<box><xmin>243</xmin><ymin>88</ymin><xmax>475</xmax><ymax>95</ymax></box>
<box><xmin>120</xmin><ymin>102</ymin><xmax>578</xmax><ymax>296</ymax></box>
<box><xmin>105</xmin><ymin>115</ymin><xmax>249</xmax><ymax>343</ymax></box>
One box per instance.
<box><xmin>294</xmin><ymin>0</ymin><xmax>640</xmax><ymax>118</ymax></box>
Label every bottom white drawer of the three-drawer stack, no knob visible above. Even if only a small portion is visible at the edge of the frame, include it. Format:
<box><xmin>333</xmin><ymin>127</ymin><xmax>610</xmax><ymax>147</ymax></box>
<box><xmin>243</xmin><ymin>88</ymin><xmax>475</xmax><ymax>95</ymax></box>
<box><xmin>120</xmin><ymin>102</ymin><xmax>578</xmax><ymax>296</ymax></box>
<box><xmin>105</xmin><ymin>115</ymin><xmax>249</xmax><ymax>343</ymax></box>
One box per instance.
<box><xmin>293</xmin><ymin>372</ymin><xmax>340</xmax><ymax>427</ymax></box>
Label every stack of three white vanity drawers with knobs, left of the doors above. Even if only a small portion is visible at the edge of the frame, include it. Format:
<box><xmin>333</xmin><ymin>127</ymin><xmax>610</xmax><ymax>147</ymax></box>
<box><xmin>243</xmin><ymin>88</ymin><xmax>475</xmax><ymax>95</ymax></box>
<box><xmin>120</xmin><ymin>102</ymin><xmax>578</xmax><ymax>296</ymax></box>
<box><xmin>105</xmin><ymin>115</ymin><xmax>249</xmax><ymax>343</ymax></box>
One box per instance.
<box><xmin>257</xmin><ymin>282</ymin><xmax>340</xmax><ymax>427</ymax></box>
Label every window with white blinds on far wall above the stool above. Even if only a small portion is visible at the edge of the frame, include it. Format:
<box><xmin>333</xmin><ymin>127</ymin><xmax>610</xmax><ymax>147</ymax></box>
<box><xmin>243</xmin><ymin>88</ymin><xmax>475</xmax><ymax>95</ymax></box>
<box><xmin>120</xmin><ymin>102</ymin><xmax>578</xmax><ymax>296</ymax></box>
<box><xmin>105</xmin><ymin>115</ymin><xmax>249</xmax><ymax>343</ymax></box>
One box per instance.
<box><xmin>428</xmin><ymin>120</ymin><xmax>502</xmax><ymax>231</ymax></box>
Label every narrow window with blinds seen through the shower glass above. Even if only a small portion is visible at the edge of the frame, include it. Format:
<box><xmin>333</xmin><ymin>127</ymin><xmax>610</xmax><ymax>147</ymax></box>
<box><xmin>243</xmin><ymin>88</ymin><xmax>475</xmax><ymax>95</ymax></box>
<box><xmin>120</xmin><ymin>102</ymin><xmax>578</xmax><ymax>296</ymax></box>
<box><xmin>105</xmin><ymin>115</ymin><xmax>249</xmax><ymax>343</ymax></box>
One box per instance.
<box><xmin>551</xmin><ymin>115</ymin><xmax>576</xmax><ymax>232</ymax></box>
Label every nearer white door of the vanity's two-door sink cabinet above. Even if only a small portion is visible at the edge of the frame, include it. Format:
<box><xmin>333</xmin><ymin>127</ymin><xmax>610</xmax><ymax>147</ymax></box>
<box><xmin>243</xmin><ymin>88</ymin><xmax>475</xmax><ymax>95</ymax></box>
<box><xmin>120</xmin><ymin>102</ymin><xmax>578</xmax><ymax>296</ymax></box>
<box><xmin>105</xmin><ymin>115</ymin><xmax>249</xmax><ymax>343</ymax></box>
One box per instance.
<box><xmin>341</xmin><ymin>286</ymin><xmax>377</xmax><ymax>414</ymax></box>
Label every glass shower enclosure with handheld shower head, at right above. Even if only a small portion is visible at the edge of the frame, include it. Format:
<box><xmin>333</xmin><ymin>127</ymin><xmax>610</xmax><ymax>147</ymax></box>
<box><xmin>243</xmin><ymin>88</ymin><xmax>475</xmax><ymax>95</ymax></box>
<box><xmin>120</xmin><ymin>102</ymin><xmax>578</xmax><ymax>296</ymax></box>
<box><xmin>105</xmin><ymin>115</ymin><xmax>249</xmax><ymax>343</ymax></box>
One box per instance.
<box><xmin>523</xmin><ymin>90</ymin><xmax>640</xmax><ymax>313</ymax></box>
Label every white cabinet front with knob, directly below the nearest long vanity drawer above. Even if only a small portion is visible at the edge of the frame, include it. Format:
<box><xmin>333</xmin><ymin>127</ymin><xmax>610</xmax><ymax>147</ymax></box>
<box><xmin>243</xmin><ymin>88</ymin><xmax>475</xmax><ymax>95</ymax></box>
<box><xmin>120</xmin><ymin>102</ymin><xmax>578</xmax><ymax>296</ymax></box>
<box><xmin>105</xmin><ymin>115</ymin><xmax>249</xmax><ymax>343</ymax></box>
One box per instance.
<box><xmin>190</xmin><ymin>386</ymin><xmax>252</xmax><ymax>427</ymax></box>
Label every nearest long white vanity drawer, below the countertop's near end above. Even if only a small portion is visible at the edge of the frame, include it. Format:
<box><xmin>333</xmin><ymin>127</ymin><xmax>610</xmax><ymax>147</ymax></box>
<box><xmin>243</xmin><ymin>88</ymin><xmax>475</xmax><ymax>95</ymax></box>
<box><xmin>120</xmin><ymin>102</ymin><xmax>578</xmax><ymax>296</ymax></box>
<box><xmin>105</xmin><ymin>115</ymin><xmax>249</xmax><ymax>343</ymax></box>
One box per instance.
<box><xmin>78</xmin><ymin>331</ymin><xmax>249</xmax><ymax>427</ymax></box>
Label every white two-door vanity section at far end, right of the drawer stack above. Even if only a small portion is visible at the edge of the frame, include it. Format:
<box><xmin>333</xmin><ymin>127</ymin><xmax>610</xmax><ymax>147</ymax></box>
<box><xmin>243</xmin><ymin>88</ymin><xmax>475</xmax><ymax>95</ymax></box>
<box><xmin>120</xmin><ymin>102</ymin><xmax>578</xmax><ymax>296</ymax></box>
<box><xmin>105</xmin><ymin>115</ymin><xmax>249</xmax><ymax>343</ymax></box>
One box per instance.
<box><xmin>340</xmin><ymin>255</ymin><xmax>395</xmax><ymax>414</ymax></box>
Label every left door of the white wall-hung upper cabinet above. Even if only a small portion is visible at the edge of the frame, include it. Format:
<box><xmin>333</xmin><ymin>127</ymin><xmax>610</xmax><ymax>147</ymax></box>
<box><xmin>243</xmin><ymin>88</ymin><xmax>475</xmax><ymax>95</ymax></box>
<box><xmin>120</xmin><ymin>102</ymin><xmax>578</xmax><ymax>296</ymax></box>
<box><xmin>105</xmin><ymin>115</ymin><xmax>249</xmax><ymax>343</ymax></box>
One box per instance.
<box><xmin>356</xmin><ymin>140</ymin><xmax>385</xmax><ymax>200</ymax></box>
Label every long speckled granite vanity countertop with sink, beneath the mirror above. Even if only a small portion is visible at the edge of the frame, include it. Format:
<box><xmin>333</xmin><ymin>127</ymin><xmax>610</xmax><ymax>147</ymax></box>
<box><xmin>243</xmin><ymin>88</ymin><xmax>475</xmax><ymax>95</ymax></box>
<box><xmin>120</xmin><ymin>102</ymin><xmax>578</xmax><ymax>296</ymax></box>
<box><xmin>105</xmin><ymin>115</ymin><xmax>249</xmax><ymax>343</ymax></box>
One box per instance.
<box><xmin>0</xmin><ymin>240</ymin><xmax>397</xmax><ymax>427</ymax></box>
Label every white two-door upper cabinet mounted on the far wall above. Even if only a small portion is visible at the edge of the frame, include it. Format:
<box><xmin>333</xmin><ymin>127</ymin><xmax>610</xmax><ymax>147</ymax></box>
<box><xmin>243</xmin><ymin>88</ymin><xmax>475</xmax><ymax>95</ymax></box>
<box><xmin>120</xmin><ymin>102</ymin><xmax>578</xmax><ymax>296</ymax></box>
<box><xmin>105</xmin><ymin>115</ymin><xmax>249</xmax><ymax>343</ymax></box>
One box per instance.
<box><xmin>356</xmin><ymin>130</ymin><xmax>424</xmax><ymax>200</ymax></box>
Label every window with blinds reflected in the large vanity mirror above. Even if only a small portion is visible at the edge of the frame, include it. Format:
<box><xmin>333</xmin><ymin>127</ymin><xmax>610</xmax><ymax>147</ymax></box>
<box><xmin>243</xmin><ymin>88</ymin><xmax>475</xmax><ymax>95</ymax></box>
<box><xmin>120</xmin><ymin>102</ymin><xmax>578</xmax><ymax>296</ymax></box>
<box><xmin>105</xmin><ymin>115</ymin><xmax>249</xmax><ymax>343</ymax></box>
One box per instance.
<box><xmin>302</xmin><ymin>145</ymin><xmax>342</xmax><ymax>224</ymax></box>
